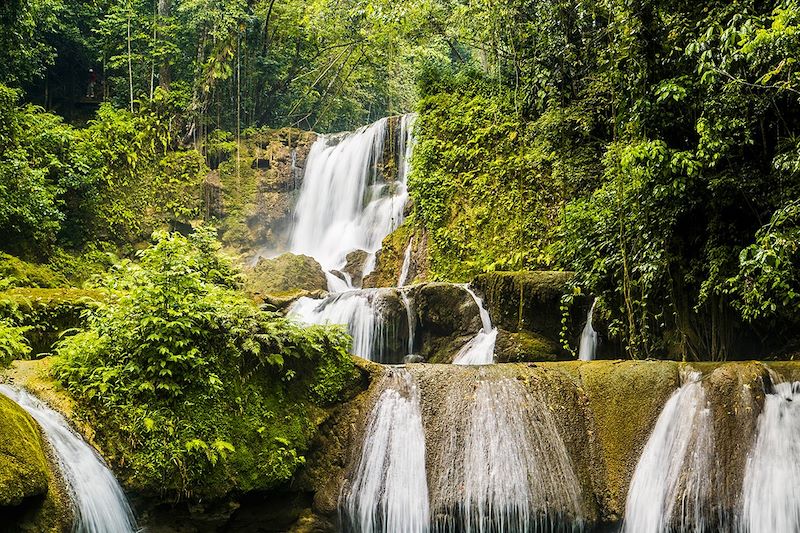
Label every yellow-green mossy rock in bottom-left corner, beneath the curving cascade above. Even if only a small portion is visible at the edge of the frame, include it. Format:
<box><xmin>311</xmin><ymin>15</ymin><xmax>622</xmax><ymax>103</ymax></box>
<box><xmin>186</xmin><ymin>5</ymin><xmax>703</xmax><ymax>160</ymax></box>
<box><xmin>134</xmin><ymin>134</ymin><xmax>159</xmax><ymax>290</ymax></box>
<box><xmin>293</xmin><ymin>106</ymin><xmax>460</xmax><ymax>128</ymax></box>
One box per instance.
<box><xmin>0</xmin><ymin>394</ymin><xmax>71</xmax><ymax>532</ymax></box>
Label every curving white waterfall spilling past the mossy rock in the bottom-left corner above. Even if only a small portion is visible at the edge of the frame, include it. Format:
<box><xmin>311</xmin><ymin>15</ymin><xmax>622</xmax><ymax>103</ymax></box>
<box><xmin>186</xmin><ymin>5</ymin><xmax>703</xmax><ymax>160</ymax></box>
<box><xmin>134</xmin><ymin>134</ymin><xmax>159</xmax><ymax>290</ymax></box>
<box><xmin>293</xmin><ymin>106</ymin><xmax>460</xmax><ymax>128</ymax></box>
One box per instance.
<box><xmin>0</xmin><ymin>385</ymin><xmax>137</xmax><ymax>533</ymax></box>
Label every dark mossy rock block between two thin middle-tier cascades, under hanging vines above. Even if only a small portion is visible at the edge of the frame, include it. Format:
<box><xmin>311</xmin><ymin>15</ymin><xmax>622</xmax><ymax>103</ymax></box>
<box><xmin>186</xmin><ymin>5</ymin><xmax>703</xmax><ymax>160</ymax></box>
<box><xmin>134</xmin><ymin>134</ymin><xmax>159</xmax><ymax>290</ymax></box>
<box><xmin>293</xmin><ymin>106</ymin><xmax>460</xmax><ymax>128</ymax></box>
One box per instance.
<box><xmin>470</xmin><ymin>271</ymin><xmax>596</xmax><ymax>362</ymax></box>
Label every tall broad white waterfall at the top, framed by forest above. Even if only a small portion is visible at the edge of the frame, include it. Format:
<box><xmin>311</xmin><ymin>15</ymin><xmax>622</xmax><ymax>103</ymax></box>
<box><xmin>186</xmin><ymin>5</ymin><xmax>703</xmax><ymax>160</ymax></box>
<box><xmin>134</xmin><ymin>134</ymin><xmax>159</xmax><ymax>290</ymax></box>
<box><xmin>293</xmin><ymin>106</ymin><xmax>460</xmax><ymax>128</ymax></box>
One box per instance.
<box><xmin>290</xmin><ymin>115</ymin><xmax>414</xmax><ymax>286</ymax></box>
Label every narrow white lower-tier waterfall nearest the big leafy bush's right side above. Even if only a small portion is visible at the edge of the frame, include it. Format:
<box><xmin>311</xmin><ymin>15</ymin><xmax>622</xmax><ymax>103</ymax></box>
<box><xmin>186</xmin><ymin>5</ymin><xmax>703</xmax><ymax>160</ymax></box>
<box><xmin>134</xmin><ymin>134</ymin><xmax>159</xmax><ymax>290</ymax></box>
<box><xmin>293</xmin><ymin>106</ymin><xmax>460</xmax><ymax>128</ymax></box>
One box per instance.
<box><xmin>339</xmin><ymin>369</ymin><xmax>430</xmax><ymax>533</ymax></box>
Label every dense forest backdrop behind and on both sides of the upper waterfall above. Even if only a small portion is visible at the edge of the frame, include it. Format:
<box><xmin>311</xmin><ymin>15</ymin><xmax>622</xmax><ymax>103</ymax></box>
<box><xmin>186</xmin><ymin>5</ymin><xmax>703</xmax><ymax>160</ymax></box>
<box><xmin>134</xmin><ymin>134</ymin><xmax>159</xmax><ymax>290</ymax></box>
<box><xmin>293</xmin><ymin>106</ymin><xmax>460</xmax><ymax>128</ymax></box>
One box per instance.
<box><xmin>0</xmin><ymin>0</ymin><xmax>800</xmax><ymax>359</ymax></box>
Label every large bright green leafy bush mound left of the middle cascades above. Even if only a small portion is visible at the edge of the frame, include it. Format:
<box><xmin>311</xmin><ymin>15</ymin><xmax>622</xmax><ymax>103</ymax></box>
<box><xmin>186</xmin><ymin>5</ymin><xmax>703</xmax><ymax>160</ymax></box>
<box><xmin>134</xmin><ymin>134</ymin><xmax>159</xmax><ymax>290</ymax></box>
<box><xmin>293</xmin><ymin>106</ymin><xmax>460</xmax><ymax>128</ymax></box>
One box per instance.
<box><xmin>55</xmin><ymin>228</ymin><xmax>355</xmax><ymax>497</ymax></box>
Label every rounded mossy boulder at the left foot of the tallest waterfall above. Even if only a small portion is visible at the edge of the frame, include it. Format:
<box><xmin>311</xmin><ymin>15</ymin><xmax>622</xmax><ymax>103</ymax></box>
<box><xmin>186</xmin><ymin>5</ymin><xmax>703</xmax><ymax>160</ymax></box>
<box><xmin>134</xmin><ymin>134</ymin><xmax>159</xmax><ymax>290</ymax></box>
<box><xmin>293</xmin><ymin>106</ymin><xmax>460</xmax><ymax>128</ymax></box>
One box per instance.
<box><xmin>246</xmin><ymin>253</ymin><xmax>328</xmax><ymax>300</ymax></box>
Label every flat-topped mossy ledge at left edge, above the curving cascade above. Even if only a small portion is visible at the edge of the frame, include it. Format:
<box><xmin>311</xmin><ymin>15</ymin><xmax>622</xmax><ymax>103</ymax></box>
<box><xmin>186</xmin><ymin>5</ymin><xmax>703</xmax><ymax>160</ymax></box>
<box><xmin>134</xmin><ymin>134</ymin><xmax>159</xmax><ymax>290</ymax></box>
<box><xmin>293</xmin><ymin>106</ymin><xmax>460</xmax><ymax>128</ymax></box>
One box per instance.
<box><xmin>0</xmin><ymin>287</ymin><xmax>106</xmax><ymax>356</ymax></box>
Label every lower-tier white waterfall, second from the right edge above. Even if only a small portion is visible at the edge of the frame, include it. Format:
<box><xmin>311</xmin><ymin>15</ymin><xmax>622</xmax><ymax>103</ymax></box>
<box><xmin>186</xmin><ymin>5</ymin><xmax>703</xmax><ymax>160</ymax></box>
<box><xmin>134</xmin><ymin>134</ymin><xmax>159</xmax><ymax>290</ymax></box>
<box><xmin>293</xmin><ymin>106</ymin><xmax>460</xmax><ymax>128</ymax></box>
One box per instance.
<box><xmin>622</xmin><ymin>372</ymin><xmax>716</xmax><ymax>533</ymax></box>
